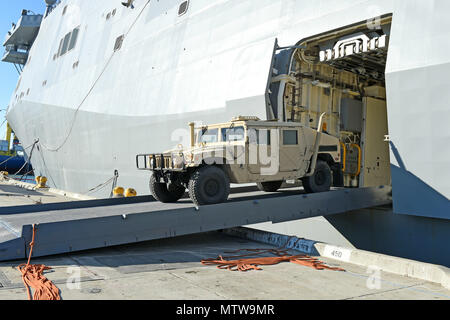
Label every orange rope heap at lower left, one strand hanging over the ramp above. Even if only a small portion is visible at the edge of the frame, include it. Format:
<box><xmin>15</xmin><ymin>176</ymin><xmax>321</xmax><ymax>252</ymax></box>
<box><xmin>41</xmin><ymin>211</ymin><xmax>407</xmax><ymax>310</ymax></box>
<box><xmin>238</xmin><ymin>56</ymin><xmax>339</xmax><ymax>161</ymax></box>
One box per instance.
<box><xmin>17</xmin><ymin>225</ymin><xmax>61</xmax><ymax>300</ymax></box>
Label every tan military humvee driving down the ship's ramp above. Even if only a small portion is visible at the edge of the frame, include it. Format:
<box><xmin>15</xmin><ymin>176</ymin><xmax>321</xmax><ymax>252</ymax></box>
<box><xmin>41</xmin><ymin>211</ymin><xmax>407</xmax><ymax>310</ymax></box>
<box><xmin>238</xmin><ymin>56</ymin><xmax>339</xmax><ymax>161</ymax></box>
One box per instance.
<box><xmin>136</xmin><ymin>114</ymin><xmax>341</xmax><ymax>205</ymax></box>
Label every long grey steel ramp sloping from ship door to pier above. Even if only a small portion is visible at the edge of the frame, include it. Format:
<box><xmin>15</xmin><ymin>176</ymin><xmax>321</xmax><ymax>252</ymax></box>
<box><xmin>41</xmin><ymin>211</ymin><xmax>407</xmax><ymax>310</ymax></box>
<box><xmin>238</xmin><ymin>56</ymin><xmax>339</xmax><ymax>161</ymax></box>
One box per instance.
<box><xmin>0</xmin><ymin>187</ymin><xmax>392</xmax><ymax>261</ymax></box>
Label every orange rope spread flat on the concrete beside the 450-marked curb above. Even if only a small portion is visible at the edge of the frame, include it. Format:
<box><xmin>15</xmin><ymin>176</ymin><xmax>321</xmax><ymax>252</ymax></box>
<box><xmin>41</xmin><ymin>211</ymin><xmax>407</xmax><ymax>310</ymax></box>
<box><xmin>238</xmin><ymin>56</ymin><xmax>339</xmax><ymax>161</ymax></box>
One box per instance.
<box><xmin>201</xmin><ymin>249</ymin><xmax>345</xmax><ymax>272</ymax></box>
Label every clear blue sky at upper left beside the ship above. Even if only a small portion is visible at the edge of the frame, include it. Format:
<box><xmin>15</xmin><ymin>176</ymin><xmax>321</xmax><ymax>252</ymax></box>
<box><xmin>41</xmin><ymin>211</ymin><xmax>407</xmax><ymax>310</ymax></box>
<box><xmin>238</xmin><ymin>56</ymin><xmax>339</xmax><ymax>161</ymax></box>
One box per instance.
<box><xmin>0</xmin><ymin>0</ymin><xmax>45</xmax><ymax>139</ymax></box>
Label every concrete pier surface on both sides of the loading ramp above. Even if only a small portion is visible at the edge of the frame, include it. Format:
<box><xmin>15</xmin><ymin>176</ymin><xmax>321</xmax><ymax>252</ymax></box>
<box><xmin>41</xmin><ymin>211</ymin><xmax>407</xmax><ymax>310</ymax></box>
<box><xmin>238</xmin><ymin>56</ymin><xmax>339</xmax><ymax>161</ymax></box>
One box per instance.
<box><xmin>0</xmin><ymin>184</ymin><xmax>450</xmax><ymax>300</ymax></box>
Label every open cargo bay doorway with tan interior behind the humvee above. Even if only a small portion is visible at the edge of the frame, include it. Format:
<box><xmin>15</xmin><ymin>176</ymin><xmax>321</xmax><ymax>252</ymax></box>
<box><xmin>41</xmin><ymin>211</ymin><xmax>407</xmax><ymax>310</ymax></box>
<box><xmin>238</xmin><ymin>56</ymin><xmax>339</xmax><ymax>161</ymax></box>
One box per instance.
<box><xmin>268</xmin><ymin>16</ymin><xmax>392</xmax><ymax>187</ymax></box>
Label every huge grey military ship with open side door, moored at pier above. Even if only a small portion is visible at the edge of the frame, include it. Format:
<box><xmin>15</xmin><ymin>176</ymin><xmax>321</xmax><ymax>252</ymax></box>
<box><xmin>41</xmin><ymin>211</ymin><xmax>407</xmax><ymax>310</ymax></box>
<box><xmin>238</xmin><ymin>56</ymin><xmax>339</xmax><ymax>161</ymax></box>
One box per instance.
<box><xmin>3</xmin><ymin>0</ymin><xmax>450</xmax><ymax>266</ymax></box>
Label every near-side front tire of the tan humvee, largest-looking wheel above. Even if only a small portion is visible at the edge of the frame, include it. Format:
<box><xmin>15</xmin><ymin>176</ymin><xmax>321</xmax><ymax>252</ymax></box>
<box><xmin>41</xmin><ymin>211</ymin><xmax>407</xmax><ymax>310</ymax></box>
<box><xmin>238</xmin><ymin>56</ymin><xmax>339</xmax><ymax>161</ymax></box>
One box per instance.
<box><xmin>189</xmin><ymin>166</ymin><xmax>230</xmax><ymax>205</ymax></box>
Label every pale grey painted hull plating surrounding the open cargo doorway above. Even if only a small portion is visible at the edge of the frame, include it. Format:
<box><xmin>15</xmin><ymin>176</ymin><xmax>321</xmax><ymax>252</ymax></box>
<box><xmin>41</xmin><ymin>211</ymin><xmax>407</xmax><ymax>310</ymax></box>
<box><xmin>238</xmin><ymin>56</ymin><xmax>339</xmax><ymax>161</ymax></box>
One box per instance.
<box><xmin>7</xmin><ymin>0</ymin><xmax>450</xmax><ymax>260</ymax></box>
